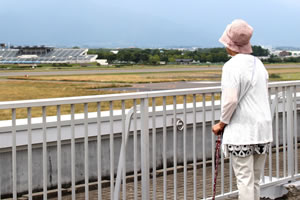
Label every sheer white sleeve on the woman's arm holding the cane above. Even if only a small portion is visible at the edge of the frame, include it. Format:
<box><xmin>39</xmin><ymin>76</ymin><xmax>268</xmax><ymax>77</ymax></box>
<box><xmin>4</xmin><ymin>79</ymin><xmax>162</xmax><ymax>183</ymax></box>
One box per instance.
<box><xmin>220</xmin><ymin>66</ymin><xmax>241</xmax><ymax>124</ymax></box>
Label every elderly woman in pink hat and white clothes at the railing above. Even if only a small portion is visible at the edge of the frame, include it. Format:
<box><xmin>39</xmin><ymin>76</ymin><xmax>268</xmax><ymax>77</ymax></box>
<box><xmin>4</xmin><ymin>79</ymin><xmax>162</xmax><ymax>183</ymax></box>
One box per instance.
<box><xmin>212</xmin><ymin>19</ymin><xmax>273</xmax><ymax>200</ymax></box>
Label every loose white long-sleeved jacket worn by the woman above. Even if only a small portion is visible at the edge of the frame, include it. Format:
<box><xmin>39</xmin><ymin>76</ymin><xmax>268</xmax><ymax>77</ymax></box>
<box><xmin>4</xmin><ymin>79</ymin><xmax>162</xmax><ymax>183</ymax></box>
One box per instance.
<box><xmin>220</xmin><ymin>54</ymin><xmax>273</xmax><ymax>145</ymax></box>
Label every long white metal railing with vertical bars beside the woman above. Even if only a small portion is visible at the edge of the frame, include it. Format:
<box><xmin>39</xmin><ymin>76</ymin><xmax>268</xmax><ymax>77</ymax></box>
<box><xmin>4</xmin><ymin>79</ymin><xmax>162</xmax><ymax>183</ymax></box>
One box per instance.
<box><xmin>0</xmin><ymin>81</ymin><xmax>300</xmax><ymax>200</ymax></box>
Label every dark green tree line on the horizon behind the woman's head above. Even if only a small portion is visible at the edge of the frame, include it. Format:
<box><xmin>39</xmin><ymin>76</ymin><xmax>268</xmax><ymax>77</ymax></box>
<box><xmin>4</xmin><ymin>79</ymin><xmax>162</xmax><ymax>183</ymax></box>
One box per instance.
<box><xmin>88</xmin><ymin>46</ymin><xmax>269</xmax><ymax>65</ymax></box>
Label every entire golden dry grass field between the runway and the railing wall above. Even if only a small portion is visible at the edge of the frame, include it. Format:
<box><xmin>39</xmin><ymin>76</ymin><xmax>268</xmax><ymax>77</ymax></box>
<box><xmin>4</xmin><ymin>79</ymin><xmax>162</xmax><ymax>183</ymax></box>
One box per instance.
<box><xmin>0</xmin><ymin>65</ymin><xmax>300</xmax><ymax>120</ymax></box>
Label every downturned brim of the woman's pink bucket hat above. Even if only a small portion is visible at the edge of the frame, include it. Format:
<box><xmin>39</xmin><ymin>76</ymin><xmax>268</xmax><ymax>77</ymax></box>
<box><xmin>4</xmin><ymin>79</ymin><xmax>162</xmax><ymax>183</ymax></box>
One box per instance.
<box><xmin>219</xmin><ymin>24</ymin><xmax>252</xmax><ymax>54</ymax></box>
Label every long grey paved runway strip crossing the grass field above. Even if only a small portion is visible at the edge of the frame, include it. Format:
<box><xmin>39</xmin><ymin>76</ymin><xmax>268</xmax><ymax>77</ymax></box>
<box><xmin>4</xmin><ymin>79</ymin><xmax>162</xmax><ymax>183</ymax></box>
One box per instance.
<box><xmin>0</xmin><ymin>64</ymin><xmax>300</xmax><ymax>77</ymax></box>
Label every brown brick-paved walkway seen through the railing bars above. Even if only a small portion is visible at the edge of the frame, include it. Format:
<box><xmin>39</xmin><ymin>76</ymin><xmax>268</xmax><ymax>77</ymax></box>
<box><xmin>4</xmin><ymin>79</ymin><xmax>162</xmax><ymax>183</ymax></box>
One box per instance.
<box><xmin>45</xmin><ymin>145</ymin><xmax>300</xmax><ymax>200</ymax></box>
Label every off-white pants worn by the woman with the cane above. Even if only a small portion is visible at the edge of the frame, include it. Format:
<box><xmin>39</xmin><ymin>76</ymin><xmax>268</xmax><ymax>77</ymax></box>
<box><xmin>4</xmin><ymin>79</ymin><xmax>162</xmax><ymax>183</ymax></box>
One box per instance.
<box><xmin>232</xmin><ymin>154</ymin><xmax>266</xmax><ymax>200</ymax></box>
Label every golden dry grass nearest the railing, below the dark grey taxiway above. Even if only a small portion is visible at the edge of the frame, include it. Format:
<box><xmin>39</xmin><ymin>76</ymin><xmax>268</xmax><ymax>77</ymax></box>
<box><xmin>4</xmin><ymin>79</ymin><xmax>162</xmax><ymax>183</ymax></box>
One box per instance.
<box><xmin>0</xmin><ymin>78</ymin><xmax>220</xmax><ymax>120</ymax></box>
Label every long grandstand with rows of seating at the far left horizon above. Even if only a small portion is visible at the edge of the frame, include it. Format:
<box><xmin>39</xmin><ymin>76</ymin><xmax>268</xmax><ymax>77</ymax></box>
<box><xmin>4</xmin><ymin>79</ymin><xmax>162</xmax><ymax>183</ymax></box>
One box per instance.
<box><xmin>0</xmin><ymin>46</ymin><xmax>97</xmax><ymax>64</ymax></box>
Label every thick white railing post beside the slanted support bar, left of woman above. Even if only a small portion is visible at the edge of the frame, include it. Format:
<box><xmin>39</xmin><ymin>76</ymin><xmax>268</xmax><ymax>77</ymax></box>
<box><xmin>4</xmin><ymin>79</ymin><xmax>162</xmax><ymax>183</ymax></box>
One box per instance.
<box><xmin>141</xmin><ymin>98</ymin><xmax>149</xmax><ymax>200</ymax></box>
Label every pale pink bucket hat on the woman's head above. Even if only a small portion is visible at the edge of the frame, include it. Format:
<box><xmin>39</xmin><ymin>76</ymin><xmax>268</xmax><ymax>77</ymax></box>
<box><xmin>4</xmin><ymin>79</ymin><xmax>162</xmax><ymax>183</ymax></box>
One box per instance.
<box><xmin>219</xmin><ymin>19</ymin><xmax>253</xmax><ymax>54</ymax></box>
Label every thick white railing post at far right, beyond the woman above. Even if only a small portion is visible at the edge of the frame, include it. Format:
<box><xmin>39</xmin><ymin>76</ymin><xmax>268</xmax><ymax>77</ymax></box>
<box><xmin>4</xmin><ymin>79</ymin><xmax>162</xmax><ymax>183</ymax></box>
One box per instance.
<box><xmin>286</xmin><ymin>86</ymin><xmax>294</xmax><ymax>177</ymax></box>
